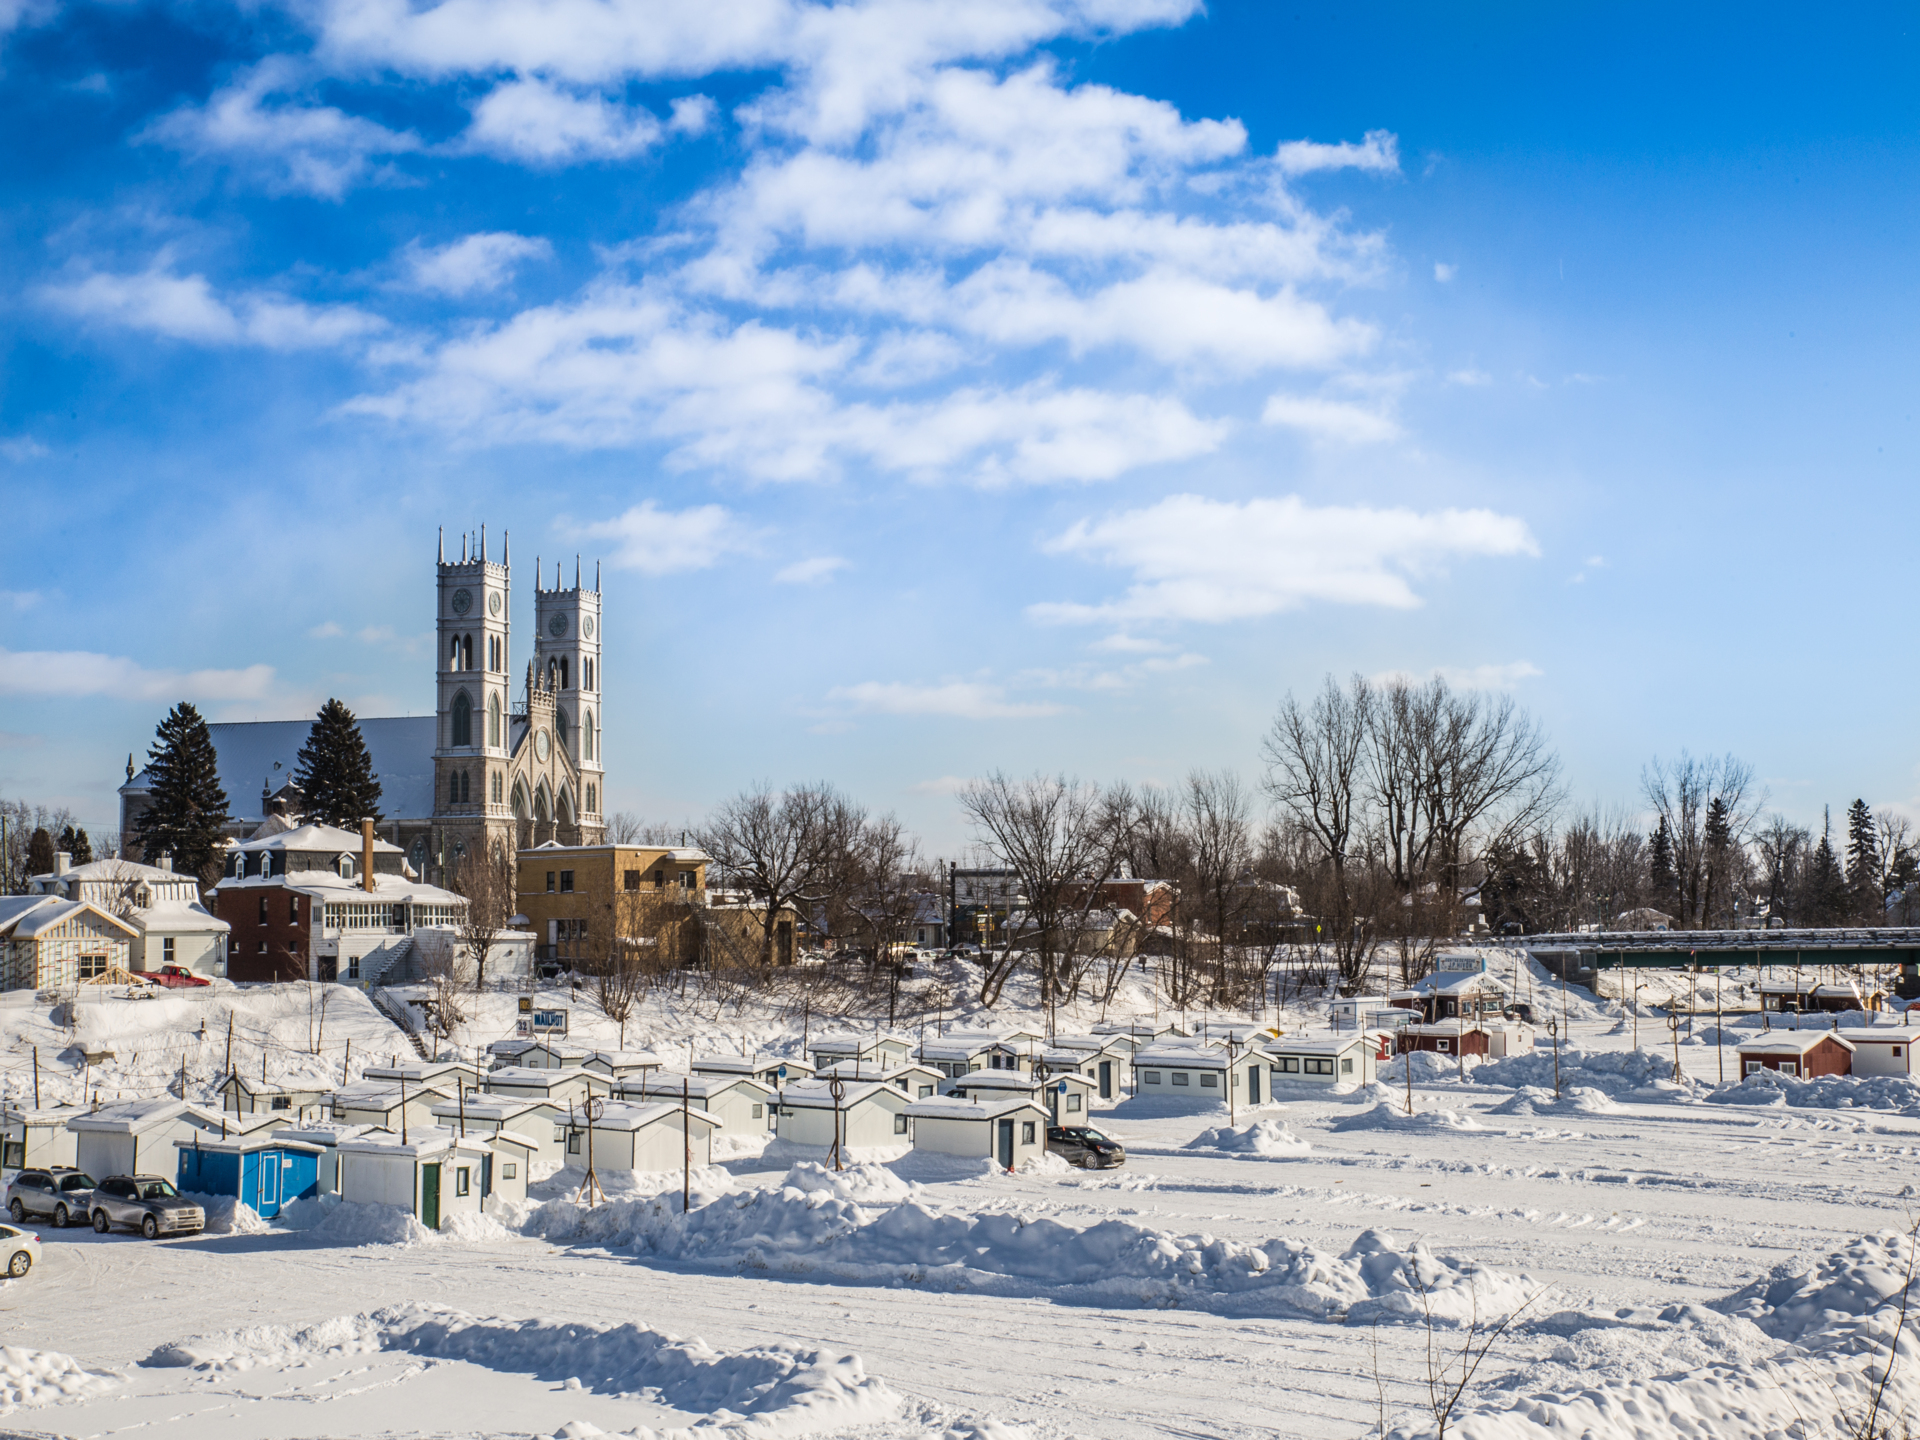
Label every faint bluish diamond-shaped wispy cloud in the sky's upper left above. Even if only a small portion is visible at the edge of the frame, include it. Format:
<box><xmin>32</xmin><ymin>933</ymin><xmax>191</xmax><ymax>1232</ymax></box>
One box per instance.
<box><xmin>138</xmin><ymin>56</ymin><xmax>422</xmax><ymax>200</ymax></box>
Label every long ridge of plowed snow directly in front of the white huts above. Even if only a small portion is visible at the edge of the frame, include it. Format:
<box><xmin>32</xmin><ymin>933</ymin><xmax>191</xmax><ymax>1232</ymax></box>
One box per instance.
<box><xmin>526</xmin><ymin>1171</ymin><xmax>1523</xmax><ymax>1323</ymax></box>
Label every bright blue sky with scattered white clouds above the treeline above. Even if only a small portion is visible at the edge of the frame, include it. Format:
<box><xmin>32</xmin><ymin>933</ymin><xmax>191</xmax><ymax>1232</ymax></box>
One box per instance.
<box><xmin>0</xmin><ymin>0</ymin><xmax>1920</xmax><ymax>851</ymax></box>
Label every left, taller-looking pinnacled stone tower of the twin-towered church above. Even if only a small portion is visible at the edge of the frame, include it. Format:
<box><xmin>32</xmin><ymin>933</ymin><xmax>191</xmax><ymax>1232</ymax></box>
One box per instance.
<box><xmin>428</xmin><ymin>526</ymin><xmax>513</xmax><ymax>883</ymax></box>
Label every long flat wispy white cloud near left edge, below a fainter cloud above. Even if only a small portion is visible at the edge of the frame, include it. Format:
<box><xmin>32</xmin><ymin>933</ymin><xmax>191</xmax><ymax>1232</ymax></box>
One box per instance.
<box><xmin>38</xmin><ymin>269</ymin><xmax>386</xmax><ymax>349</ymax></box>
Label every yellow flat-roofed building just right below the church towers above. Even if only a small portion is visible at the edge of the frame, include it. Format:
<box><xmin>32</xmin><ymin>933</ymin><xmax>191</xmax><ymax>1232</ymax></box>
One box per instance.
<box><xmin>518</xmin><ymin>845</ymin><xmax>707</xmax><ymax>970</ymax></box>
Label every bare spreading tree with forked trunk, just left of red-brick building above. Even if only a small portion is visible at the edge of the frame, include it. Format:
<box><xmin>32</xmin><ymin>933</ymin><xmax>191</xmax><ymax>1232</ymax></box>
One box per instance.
<box><xmin>960</xmin><ymin>770</ymin><xmax>1139</xmax><ymax>1010</ymax></box>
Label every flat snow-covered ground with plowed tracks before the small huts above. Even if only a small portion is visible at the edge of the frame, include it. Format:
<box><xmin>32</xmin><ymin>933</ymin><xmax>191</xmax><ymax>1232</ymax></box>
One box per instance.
<box><xmin>0</xmin><ymin>948</ymin><xmax>1920</xmax><ymax>1440</ymax></box>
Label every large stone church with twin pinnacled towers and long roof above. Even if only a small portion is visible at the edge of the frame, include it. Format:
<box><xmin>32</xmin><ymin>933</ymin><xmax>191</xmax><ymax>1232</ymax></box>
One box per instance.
<box><xmin>119</xmin><ymin>528</ymin><xmax>607</xmax><ymax>885</ymax></box>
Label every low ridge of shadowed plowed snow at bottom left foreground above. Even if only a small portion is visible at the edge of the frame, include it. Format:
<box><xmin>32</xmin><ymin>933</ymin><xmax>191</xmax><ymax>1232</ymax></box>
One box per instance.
<box><xmin>147</xmin><ymin>1304</ymin><xmax>900</xmax><ymax>1440</ymax></box>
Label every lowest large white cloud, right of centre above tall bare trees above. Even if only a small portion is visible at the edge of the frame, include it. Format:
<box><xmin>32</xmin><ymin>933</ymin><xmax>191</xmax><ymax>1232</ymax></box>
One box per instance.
<box><xmin>1027</xmin><ymin>495</ymin><xmax>1538</xmax><ymax>622</ymax></box>
